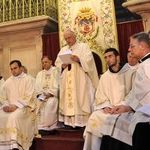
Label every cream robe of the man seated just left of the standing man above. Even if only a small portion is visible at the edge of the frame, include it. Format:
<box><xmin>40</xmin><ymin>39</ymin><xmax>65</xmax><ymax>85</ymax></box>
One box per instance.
<box><xmin>35</xmin><ymin>67</ymin><xmax>60</xmax><ymax>130</ymax></box>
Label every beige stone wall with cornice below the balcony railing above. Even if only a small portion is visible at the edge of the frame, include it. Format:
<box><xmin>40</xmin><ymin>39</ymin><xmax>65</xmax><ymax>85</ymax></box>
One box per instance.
<box><xmin>0</xmin><ymin>16</ymin><xmax>57</xmax><ymax>79</ymax></box>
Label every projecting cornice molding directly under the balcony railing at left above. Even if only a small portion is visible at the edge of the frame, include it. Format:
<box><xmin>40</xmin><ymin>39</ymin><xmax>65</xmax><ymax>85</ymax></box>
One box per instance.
<box><xmin>0</xmin><ymin>15</ymin><xmax>58</xmax><ymax>34</ymax></box>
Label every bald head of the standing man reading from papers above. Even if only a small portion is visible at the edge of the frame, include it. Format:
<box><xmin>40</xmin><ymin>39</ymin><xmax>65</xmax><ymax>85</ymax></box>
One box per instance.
<box><xmin>64</xmin><ymin>29</ymin><xmax>76</xmax><ymax>46</ymax></box>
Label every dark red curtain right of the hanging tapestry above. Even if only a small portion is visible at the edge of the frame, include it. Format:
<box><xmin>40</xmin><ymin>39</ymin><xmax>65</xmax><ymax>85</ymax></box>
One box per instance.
<box><xmin>117</xmin><ymin>20</ymin><xmax>144</xmax><ymax>62</ymax></box>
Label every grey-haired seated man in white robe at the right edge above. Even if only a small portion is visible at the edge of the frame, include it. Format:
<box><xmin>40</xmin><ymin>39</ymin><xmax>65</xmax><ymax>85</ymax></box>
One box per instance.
<box><xmin>101</xmin><ymin>32</ymin><xmax>150</xmax><ymax>145</ymax></box>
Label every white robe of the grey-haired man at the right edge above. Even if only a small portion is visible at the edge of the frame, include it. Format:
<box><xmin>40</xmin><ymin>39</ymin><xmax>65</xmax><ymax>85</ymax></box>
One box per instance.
<box><xmin>101</xmin><ymin>59</ymin><xmax>150</xmax><ymax>145</ymax></box>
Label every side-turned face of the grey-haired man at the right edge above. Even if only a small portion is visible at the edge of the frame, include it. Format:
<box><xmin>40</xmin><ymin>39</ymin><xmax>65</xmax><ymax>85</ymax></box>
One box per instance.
<box><xmin>128</xmin><ymin>38</ymin><xmax>143</xmax><ymax>59</ymax></box>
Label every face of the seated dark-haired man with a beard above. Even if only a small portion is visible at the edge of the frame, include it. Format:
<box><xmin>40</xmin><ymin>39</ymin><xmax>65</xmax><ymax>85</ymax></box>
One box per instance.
<box><xmin>104</xmin><ymin>52</ymin><xmax>119</xmax><ymax>67</ymax></box>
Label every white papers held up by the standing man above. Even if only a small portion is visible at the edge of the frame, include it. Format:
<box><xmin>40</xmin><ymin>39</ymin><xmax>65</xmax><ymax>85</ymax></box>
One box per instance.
<box><xmin>59</xmin><ymin>50</ymin><xmax>72</xmax><ymax>64</ymax></box>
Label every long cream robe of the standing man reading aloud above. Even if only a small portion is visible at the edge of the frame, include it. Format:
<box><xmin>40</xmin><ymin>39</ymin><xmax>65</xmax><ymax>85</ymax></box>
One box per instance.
<box><xmin>55</xmin><ymin>43</ymin><xmax>98</xmax><ymax>127</ymax></box>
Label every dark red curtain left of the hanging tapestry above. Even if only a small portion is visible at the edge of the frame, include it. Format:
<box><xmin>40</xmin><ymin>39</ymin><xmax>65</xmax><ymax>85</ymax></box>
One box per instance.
<box><xmin>42</xmin><ymin>32</ymin><xmax>60</xmax><ymax>64</ymax></box>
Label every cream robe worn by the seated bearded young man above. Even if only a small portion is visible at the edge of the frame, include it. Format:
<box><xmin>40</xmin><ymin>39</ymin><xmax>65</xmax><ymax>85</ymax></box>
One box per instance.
<box><xmin>84</xmin><ymin>64</ymin><xmax>136</xmax><ymax>150</ymax></box>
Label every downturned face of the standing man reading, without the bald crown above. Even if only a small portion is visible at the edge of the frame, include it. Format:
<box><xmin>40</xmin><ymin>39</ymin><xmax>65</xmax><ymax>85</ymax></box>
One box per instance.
<box><xmin>64</xmin><ymin>33</ymin><xmax>76</xmax><ymax>46</ymax></box>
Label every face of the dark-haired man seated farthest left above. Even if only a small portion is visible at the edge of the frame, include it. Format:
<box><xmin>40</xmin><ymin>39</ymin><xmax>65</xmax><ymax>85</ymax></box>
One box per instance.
<box><xmin>10</xmin><ymin>63</ymin><xmax>22</xmax><ymax>77</ymax></box>
